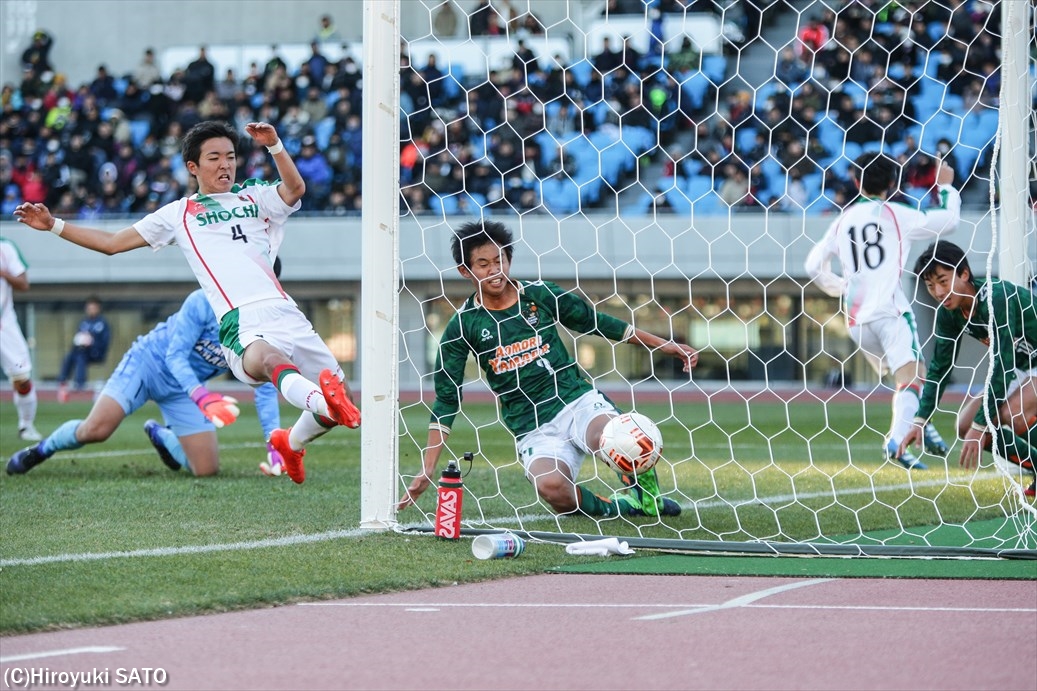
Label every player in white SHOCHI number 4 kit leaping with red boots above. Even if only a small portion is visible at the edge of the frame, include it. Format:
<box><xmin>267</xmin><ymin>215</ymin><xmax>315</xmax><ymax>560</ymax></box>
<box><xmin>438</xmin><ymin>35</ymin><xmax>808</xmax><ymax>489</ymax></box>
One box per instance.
<box><xmin>15</xmin><ymin>121</ymin><xmax>360</xmax><ymax>482</ymax></box>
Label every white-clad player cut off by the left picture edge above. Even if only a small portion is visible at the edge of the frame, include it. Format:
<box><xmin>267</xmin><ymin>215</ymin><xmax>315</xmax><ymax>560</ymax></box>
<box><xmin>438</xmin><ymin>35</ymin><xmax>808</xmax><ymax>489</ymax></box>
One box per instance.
<box><xmin>0</xmin><ymin>238</ymin><xmax>41</xmax><ymax>441</ymax></box>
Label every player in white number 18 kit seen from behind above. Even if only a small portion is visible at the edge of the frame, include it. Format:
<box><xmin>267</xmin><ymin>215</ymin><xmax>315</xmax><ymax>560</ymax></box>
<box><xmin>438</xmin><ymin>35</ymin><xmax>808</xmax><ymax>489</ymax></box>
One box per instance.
<box><xmin>806</xmin><ymin>153</ymin><xmax>961</xmax><ymax>470</ymax></box>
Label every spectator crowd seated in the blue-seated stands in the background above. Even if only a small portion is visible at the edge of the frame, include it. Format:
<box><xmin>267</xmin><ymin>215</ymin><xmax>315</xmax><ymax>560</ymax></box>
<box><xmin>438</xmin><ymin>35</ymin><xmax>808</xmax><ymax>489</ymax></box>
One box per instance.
<box><xmin>0</xmin><ymin>0</ymin><xmax>1012</xmax><ymax>219</ymax></box>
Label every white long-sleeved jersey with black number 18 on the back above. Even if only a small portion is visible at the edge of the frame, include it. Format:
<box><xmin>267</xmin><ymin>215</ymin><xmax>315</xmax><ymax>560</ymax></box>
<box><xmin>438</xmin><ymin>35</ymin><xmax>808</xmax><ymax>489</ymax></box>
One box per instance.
<box><xmin>806</xmin><ymin>185</ymin><xmax>961</xmax><ymax>326</ymax></box>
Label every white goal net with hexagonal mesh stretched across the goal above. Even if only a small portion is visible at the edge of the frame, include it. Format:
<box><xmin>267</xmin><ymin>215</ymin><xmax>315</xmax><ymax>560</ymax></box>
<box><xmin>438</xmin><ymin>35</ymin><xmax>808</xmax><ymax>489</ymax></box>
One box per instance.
<box><xmin>362</xmin><ymin>0</ymin><xmax>1037</xmax><ymax>556</ymax></box>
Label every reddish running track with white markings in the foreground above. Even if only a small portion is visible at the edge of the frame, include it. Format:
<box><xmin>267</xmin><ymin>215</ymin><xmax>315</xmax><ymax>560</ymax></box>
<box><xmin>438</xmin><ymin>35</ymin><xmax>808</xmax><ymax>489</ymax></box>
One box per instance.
<box><xmin>0</xmin><ymin>575</ymin><xmax>1037</xmax><ymax>691</ymax></box>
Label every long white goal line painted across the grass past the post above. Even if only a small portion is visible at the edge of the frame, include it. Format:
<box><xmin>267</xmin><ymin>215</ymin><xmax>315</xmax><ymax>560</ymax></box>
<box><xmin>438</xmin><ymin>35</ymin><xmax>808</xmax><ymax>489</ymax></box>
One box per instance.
<box><xmin>0</xmin><ymin>473</ymin><xmax>1012</xmax><ymax>569</ymax></box>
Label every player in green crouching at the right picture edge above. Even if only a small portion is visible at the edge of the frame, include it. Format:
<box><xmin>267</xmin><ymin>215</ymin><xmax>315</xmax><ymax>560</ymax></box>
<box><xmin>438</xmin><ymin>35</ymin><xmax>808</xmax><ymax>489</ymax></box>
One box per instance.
<box><xmin>902</xmin><ymin>242</ymin><xmax>1037</xmax><ymax>496</ymax></box>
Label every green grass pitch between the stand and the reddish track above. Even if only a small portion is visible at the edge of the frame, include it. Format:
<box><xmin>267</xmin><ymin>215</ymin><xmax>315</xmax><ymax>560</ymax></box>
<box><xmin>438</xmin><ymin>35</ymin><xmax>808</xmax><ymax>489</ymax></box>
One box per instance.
<box><xmin>0</xmin><ymin>400</ymin><xmax>1033</xmax><ymax>633</ymax></box>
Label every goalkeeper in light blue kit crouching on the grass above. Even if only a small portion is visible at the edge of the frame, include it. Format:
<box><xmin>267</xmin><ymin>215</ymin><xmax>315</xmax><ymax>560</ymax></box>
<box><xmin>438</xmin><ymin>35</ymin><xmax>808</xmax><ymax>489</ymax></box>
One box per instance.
<box><xmin>7</xmin><ymin>288</ymin><xmax>281</xmax><ymax>475</ymax></box>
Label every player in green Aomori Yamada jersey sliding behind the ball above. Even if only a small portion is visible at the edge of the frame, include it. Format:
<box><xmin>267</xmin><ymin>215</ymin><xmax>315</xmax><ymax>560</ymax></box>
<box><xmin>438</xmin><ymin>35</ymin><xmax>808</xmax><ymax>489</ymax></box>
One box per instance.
<box><xmin>398</xmin><ymin>221</ymin><xmax>698</xmax><ymax>516</ymax></box>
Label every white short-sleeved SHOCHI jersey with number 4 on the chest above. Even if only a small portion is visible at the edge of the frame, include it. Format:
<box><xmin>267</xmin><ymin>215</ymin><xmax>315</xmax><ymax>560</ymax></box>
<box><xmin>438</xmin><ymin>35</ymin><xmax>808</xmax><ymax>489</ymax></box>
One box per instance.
<box><xmin>134</xmin><ymin>179</ymin><xmax>300</xmax><ymax>322</ymax></box>
